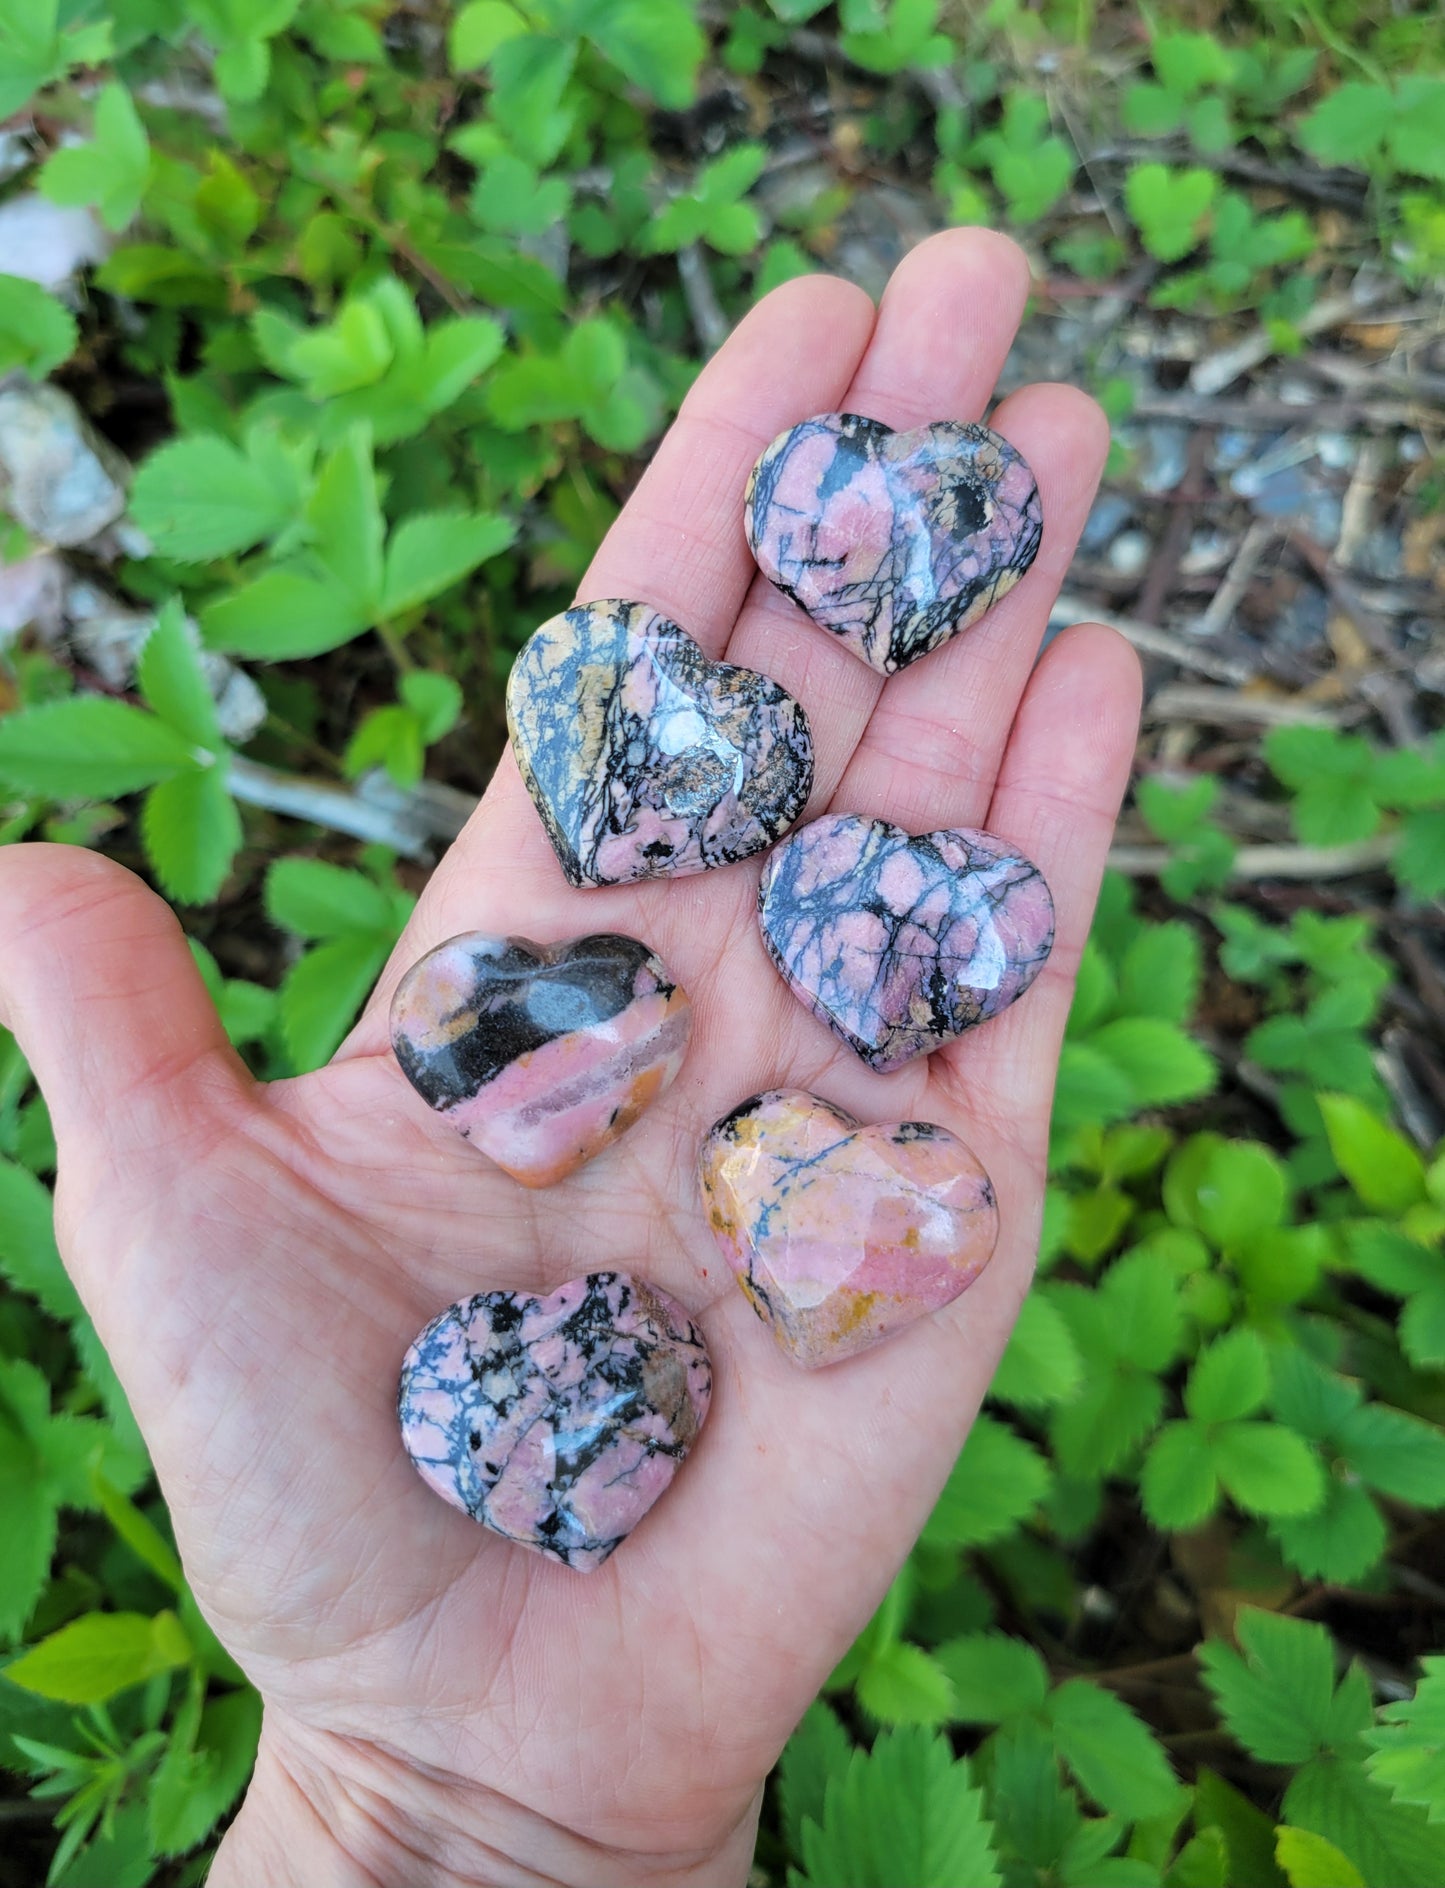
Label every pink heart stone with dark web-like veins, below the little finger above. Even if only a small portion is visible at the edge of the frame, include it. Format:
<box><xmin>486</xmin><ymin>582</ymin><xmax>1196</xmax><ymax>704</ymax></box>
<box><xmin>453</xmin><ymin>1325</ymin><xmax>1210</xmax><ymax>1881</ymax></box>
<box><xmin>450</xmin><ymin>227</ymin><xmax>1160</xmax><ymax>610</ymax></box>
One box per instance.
<box><xmin>757</xmin><ymin>814</ymin><xmax>1054</xmax><ymax>1070</ymax></box>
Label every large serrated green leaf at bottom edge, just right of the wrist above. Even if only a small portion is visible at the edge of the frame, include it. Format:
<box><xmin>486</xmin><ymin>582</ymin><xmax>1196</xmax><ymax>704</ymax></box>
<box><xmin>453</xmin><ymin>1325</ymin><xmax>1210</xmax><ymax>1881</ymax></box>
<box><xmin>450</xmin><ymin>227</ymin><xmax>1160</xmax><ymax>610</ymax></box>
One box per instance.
<box><xmin>799</xmin><ymin>1726</ymin><xmax>999</xmax><ymax>1888</ymax></box>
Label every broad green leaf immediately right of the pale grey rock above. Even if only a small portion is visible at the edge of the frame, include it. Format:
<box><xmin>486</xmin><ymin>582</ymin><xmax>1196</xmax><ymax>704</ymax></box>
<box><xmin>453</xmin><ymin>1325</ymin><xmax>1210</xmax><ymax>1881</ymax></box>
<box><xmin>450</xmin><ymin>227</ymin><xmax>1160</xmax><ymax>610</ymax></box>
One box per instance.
<box><xmin>130</xmin><ymin>434</ymin><xmax>295</xmax><ymax>563</ymax></box>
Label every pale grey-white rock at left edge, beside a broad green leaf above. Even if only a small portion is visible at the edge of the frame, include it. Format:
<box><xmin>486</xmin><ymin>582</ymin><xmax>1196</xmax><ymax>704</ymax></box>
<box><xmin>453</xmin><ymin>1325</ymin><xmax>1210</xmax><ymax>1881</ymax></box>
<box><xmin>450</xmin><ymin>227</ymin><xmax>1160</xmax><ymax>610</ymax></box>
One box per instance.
<box><xmin>0</xmin><ymin>381</ymin><xmax>130</xmax><ymax>546</ymax></box>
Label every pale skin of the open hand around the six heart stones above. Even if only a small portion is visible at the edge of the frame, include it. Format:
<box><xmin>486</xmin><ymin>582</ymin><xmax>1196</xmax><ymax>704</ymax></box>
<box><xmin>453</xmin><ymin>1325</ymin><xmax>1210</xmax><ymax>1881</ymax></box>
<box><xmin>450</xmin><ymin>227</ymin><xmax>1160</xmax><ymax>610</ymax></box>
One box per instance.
<box><xmin>0</xmin><ymin>230</ymin><xmax>1139</xmax><ymax>1888</ymax></box>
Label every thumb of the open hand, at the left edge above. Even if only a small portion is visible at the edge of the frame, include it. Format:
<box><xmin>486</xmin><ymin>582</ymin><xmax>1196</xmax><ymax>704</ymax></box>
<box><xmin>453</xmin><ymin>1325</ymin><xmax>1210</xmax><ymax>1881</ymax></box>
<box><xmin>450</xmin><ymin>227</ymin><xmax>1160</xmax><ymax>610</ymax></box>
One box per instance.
<box><xmin>0</xmin><ymin>844</ymin><xmax>249</xmax><ymax>1189</ymax></box>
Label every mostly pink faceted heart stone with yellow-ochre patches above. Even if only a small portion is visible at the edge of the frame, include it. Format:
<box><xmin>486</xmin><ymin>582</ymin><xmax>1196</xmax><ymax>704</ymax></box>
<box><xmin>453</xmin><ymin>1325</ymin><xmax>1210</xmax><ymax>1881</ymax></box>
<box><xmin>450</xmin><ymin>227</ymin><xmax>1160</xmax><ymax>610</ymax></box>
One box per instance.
<box><xmin>701</xmin><ymin>1089</ymin><xmax>999</xmax><ymax>1369</ymax></box>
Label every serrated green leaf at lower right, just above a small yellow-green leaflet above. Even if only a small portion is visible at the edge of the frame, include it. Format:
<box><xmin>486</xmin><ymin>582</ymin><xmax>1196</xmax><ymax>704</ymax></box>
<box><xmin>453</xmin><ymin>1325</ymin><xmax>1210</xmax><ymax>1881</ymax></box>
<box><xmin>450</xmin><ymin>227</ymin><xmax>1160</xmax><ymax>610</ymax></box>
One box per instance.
<box><xmin>1198</xmin><ymin>1607</ymin><xmax>1371</xmax><ymax>1765</ymax></box>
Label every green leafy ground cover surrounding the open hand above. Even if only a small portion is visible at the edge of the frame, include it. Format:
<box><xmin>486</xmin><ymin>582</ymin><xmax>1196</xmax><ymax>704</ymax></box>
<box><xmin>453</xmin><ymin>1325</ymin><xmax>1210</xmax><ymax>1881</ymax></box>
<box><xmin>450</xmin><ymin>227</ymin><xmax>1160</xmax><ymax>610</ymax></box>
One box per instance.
<box><xmin>0</xmin><ymin>0</ymin><xmax>1445</xmax><ymax>1888</ymax></box>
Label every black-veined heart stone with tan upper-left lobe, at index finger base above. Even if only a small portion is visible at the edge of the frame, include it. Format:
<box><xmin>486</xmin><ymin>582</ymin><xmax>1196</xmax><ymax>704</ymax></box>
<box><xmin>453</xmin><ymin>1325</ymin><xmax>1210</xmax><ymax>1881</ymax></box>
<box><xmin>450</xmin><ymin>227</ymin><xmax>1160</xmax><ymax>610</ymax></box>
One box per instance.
<box><xmin>506</xmin><ymin>602</ymin><xmax>812</xmax><ymax>885</ymax></box>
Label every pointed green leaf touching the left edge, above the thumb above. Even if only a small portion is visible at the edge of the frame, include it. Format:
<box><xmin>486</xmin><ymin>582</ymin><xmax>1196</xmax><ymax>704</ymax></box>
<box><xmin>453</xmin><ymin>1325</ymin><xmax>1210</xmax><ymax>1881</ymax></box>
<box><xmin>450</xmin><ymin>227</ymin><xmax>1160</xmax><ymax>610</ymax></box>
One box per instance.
<box><xmin>0</xmin><ymin>695</ymin><xmax>196</xmax><ymax>801</ymax></box>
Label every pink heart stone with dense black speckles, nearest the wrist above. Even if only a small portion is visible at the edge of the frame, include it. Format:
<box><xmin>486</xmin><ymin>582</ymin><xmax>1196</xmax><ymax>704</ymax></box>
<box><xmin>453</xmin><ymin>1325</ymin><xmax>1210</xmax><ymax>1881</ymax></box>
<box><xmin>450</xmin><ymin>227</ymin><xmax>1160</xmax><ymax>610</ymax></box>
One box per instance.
<box><xmin>397</xmin><ymin>1273</ymin><xmax>712</xmax><ymax>1573</ymax></box>
